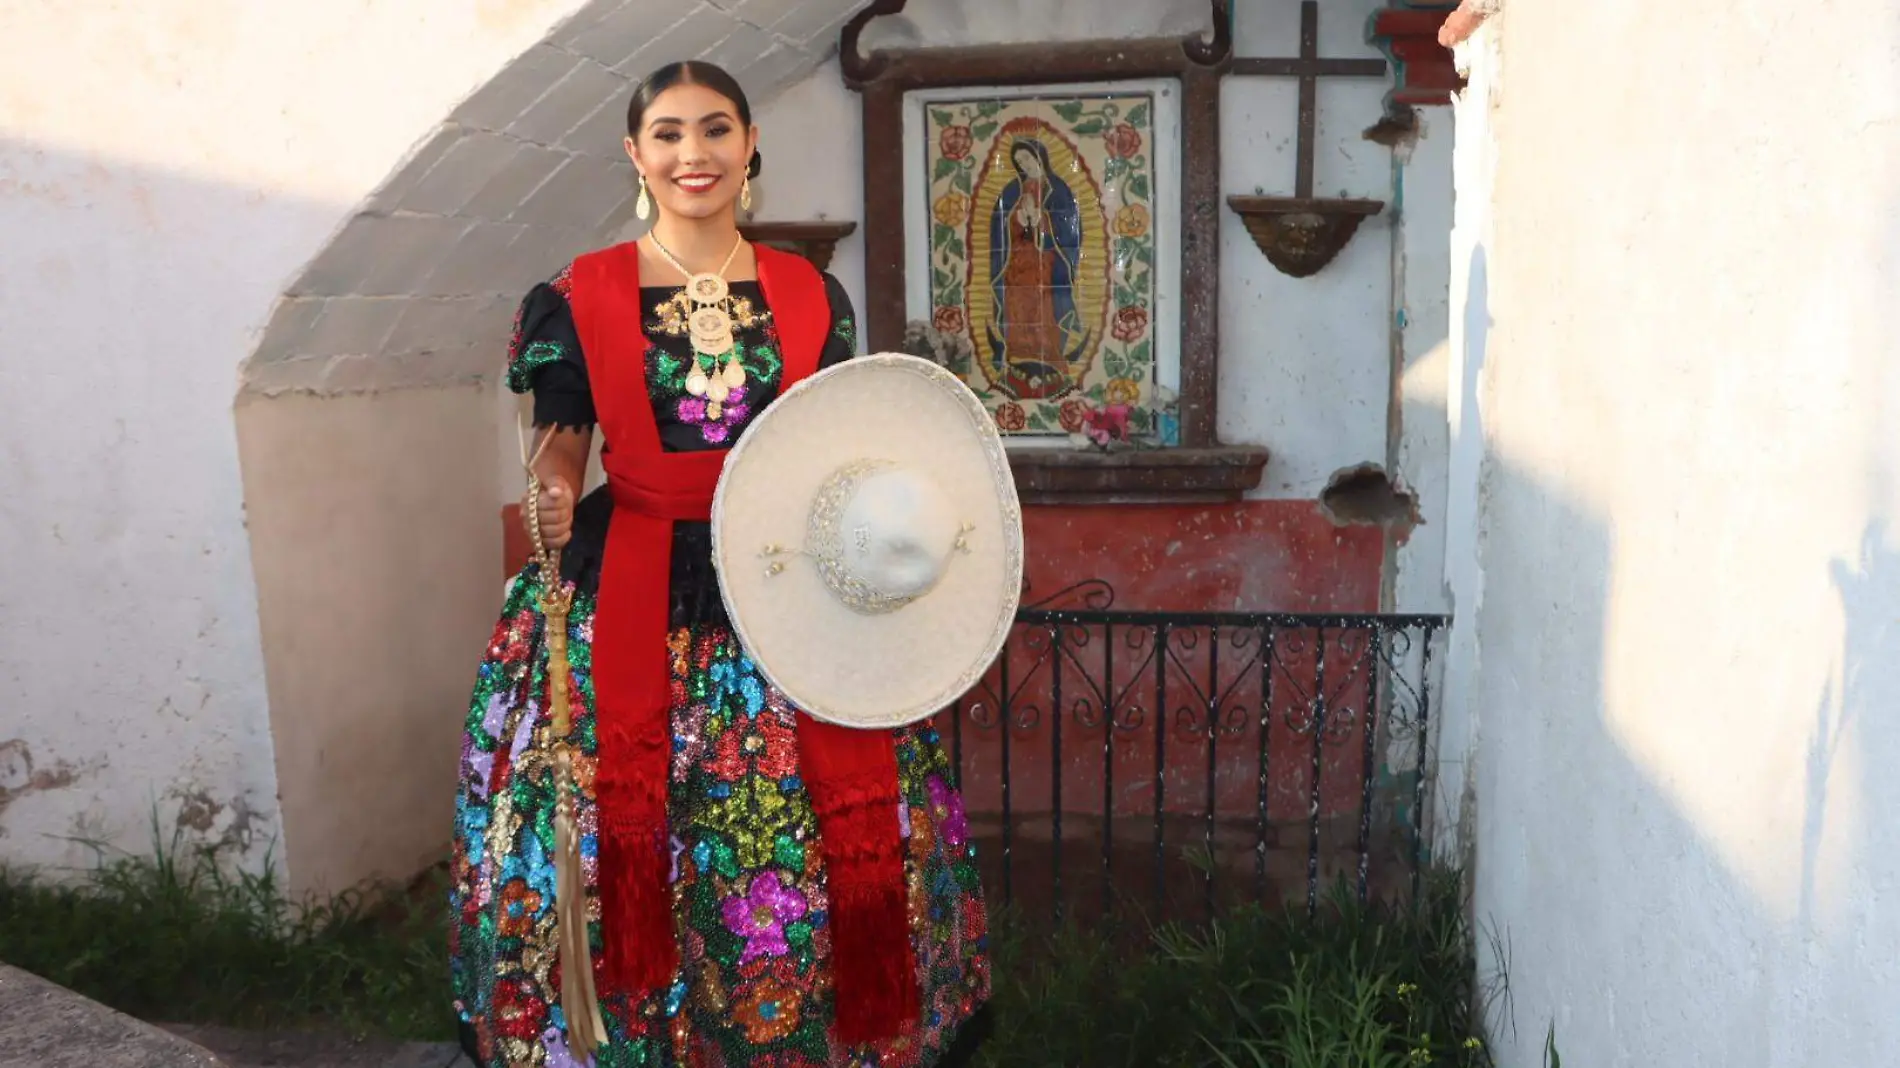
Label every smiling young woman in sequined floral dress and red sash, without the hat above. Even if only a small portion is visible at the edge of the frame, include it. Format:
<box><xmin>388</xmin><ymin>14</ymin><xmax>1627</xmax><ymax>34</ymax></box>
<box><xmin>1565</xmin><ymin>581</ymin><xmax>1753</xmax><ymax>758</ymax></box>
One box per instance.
<box><xmin>450</xmin><ymin>63</ymin><xmax>990</xmax><ymax>1068</ymax></box>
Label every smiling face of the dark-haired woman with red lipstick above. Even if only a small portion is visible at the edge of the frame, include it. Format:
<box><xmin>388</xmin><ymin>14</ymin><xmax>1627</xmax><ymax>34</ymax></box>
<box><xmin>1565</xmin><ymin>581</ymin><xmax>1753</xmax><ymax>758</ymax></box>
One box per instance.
<box><xmin>627</xmin><ymin>86</ymin><xmax>758</xmax><ymax>219</ymax></box>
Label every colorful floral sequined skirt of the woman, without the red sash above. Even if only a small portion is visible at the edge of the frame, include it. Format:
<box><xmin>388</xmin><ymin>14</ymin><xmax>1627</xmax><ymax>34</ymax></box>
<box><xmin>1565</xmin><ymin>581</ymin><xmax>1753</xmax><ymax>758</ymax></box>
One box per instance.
<box><xmin>448</xmin><ymin>564</ymin><xmax>990</xmax><ymax>1068</ymax></box>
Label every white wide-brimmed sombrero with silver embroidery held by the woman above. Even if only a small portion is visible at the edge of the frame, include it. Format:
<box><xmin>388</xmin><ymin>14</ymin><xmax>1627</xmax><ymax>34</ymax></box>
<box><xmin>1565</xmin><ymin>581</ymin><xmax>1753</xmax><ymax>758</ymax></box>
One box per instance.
<box><xmin>713</xmin><ymin>353</ymin><xmax>1022</xmax><ymax>728</ymax></box>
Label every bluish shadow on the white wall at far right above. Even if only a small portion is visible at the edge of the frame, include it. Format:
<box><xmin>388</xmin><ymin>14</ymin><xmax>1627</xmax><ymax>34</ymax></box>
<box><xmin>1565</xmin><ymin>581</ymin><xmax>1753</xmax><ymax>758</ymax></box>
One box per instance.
<box><xmin>1452</xmin><ymin>249</ymin><xmax>1900</xmax><ymax>1068</ymax></box>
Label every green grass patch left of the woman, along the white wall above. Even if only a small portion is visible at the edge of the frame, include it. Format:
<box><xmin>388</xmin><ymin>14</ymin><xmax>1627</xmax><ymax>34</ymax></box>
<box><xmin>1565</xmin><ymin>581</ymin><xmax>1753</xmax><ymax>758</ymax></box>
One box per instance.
<box><xmin>0</xmin><ymin>824</ymin><xmax>454</xmax><ymax>1039</ymax></box>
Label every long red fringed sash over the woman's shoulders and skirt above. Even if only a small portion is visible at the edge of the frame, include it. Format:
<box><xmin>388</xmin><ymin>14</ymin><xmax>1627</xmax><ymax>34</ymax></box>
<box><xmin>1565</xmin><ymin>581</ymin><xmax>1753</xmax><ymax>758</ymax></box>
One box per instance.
<box><xmin>568</xmin><ymin>243</ymin><xmax>918</xmax><ymax>1045</ymax></box>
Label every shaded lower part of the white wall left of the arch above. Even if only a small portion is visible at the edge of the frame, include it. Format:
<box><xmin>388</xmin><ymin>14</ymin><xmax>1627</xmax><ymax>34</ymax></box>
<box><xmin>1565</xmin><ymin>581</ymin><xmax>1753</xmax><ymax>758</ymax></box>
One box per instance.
<box><xmin>0</xmin><ymin>139</ymin><xmax>346</xmax><ymax>868</ymax></box>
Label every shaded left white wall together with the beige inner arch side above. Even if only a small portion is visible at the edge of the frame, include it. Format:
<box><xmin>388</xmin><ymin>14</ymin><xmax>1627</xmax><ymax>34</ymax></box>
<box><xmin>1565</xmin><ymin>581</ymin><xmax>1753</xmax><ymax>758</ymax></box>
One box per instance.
<box><xmin>0</xmin><ymin>133</ymin><xmax>505</xmax><ymax>893</ymax></box>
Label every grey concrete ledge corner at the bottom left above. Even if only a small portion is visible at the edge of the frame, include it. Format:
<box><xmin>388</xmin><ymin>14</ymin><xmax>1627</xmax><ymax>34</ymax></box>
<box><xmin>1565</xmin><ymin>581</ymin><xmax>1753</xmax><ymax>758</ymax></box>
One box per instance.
<box><xmin>0</xmin><ymin>963</ymin><xmax>228</xmax><ymax>1068</ymax></box>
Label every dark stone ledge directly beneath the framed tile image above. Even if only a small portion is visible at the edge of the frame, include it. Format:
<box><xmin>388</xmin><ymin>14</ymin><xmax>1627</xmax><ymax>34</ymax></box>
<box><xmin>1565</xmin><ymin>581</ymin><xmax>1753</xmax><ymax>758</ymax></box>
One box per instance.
<box><xmin>1009</xmin><ymin>445</ymin><xmax>1269</xmax><ymax>504</ymax></box>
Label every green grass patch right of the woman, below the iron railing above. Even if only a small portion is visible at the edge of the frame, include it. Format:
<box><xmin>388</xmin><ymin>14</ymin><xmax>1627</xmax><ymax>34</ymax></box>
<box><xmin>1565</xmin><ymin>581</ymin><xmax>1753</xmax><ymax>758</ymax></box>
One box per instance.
<box><xmin>977</xmin><ymin>874</ymin><xmax>1492</xmax><ymax>1068</ymax></box>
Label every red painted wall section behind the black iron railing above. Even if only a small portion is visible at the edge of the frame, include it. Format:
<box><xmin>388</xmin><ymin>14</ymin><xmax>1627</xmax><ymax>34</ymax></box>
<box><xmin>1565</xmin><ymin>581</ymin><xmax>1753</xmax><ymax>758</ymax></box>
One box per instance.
<box><xmin>941</xmin><ymin>500</ymin><xmax>1385</xmax><ymax>821</ymax></box>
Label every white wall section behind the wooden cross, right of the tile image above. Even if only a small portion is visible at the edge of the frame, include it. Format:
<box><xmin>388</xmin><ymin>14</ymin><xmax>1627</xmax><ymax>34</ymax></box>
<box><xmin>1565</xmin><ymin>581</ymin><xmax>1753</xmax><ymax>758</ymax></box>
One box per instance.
<box><xmin>1220</xmin><ymin>0</ymin><xmax>1397</xmax><ymax>498</ymax></box>
